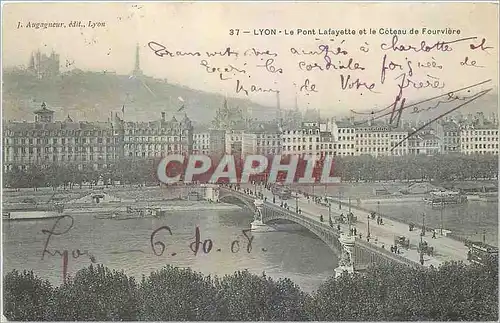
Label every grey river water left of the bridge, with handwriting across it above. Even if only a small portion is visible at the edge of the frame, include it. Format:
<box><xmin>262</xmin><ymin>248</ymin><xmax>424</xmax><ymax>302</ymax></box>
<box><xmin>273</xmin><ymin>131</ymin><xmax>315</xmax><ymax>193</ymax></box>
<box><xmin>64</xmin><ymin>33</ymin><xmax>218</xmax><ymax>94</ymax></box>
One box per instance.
<box><xmin>3</xmin><ymin>210</ymin><xmax>338</xmax><ymax>292</ymax></box>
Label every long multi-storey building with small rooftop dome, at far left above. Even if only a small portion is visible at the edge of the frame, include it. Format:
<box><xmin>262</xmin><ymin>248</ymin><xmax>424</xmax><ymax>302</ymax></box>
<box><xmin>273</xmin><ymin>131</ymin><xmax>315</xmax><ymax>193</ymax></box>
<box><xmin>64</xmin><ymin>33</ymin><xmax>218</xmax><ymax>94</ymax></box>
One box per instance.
<box><xmin>3</xmin><ymin>103</ymin><xmax>122</xmax><ymax>170</ymax></box>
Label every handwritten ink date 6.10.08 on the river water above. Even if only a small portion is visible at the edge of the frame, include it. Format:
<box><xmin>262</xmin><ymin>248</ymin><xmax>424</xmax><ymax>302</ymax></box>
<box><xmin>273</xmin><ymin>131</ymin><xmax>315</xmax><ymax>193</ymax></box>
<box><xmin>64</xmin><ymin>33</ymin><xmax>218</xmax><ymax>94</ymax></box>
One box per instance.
<box><xmin>150</xmin><ymin>225</ymin><xmax>260</xmax><ymax>256</ymax></box>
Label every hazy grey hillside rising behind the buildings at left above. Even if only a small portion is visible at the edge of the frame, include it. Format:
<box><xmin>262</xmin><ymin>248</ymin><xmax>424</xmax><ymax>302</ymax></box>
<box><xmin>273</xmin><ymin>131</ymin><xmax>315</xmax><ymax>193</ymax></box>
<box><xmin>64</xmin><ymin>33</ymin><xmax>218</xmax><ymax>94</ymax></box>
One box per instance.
<box><xmin>2</xmin><ymin>70</ymin><xmax>275</xmax><ymax>122</ymax></box>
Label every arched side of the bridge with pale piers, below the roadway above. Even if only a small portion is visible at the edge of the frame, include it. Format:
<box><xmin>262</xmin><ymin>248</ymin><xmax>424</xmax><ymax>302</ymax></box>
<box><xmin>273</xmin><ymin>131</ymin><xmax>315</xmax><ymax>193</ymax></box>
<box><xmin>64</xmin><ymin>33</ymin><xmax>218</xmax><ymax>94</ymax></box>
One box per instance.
<box><xmin>214</xmin><ymin>186</ymin><xmax>421</xmax><ymax>274</ymax></box>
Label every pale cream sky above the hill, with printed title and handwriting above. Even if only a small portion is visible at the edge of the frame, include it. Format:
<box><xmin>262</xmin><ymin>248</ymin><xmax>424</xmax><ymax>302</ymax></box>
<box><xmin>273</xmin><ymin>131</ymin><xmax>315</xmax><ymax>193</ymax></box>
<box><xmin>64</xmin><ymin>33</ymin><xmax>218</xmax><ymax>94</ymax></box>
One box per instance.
<box><xmin>2</xmin><ymin>3</ymin><xmax>499</xmax><ymax>113</ymax></box>
